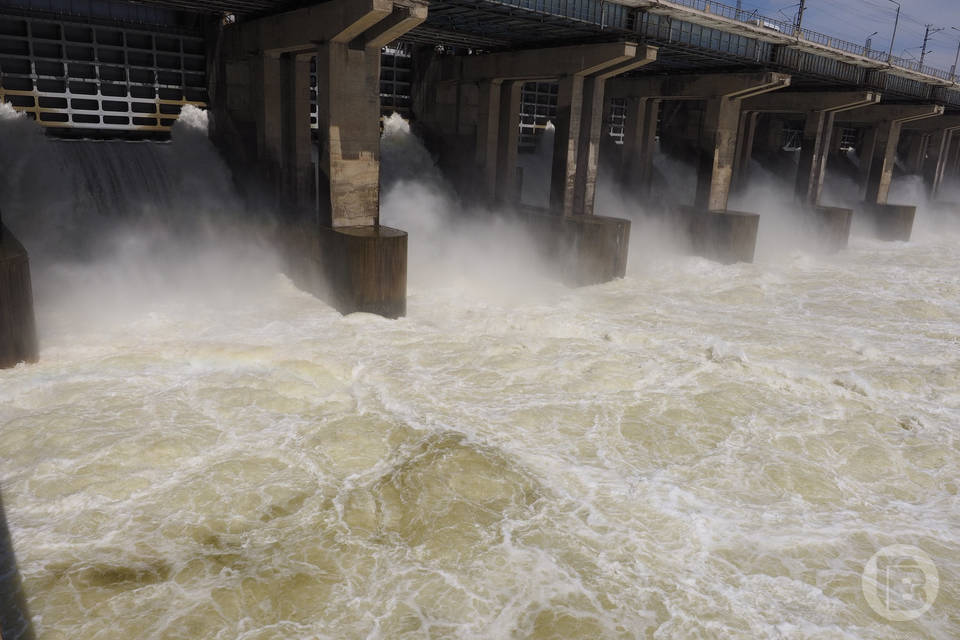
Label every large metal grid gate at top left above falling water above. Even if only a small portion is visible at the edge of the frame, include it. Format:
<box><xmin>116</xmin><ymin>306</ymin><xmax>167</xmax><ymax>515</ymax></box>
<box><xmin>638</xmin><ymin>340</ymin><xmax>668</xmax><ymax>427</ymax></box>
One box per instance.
<box><xmin>0</xmin><ymin>15</ymin><xmax>207</xmax><ymax>131</ymax></box>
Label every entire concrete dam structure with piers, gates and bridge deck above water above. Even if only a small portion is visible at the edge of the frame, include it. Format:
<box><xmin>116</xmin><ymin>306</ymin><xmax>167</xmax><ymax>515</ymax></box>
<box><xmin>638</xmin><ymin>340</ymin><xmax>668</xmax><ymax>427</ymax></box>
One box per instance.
<box><xmin>0</xmin><ymin>0</ymin><xmax>960</xmax><ymax>366</ymax></box>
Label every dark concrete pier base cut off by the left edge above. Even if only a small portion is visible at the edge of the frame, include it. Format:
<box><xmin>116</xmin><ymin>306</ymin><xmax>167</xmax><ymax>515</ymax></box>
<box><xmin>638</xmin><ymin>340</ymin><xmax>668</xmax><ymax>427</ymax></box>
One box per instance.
<box><xmin>0</xmin><ymin>224</ymin><xmax>39</xmax><ymax>369</ymax></box>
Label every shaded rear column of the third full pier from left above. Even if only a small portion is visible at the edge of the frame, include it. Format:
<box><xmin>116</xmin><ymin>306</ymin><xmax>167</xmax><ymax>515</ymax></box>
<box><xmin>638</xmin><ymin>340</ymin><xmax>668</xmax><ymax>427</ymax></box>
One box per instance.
<box><xmin>620</xmin><ymin>96</ymin><xmax>660</xmax><ymax>196</ymax></box>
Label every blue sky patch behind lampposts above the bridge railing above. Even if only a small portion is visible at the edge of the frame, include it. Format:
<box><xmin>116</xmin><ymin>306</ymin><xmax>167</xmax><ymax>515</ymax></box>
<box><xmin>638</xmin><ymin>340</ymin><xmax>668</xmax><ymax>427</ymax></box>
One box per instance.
<box><xmin>748</xmin><ymin>0</ymin><xmax>960</xmax><ymax>71</ymax></box>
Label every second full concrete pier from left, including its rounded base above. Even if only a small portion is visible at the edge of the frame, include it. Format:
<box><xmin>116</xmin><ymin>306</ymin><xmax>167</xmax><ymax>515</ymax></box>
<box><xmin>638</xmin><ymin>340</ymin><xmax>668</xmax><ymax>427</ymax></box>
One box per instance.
<box><xmin>418</xmin><ymin>42</ymin><xmax>657</xmax><ymax>286</ymax></box>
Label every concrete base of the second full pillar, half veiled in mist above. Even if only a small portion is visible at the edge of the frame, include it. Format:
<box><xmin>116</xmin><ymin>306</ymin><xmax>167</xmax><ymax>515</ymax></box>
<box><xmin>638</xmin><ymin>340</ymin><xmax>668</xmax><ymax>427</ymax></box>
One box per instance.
<box><xmin>528</xmin><ymin>212</ymin><xmax>630</xmax><ymax>287</ymax></box>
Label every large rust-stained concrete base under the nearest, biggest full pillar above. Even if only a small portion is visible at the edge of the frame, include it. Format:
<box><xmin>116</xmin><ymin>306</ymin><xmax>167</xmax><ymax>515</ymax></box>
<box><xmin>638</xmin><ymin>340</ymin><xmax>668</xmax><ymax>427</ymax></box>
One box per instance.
<box><xmin>278</xmin><ymin>226</ymin><xmax>407</xmax><ymax>318</ymax></box>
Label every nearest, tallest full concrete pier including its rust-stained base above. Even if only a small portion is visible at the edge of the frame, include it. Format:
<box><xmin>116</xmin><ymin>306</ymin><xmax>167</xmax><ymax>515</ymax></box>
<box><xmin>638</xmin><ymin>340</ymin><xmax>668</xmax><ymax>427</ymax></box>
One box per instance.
<box><xmin>214</xmin><ymin>0</ymin><xmax>427</xmax><ymax>317</ymax></box>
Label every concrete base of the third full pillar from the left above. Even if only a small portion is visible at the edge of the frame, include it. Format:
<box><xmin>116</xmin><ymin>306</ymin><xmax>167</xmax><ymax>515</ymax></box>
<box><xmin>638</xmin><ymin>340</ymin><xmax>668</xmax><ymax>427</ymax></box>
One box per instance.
<box><xmin>680</xmin><ymin>207</ymin><xmax>760</xmax><ymax>264</ymax></box>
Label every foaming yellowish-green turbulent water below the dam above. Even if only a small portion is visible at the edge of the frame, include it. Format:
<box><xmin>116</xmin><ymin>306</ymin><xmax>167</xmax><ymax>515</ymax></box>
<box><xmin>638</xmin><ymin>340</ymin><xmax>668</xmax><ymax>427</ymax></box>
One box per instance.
<box><xmin>0</xmin><ymin>107</ymin><xmax>960</xmax><ymax>640</ymax></box>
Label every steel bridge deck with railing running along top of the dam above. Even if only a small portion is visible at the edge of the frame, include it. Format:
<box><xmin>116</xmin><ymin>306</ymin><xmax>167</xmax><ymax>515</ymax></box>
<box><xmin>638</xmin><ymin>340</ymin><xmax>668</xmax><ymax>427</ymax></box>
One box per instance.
<box><xmin>79</xmin><ymin>0</ymin><xmax>960</xmax><ymax>96</ymax></box>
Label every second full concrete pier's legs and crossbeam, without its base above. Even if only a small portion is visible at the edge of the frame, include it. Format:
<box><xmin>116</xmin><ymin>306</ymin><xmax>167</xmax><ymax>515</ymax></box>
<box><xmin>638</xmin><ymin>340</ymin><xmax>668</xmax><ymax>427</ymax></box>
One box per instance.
<box><xmin>418</xmin><ymin>42</ymin><xmax>656</xmax><ymax>214</ymax></box>
